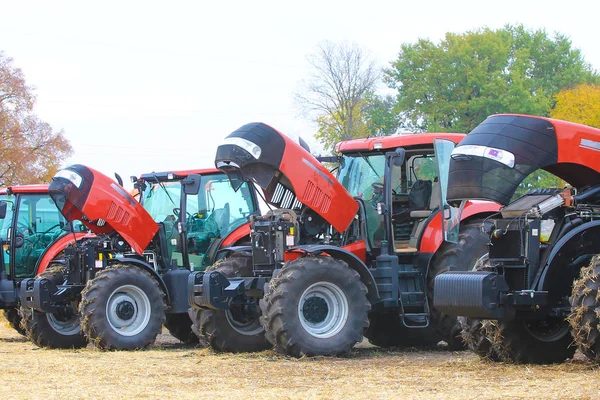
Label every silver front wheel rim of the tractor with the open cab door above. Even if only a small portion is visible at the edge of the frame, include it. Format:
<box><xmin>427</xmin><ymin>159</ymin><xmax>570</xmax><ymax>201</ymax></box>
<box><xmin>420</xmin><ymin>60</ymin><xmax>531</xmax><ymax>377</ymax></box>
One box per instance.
<box><xmin>298</xmin><ymin>282</ymin><xmax>348</xmax><ymax>339</ymax></box>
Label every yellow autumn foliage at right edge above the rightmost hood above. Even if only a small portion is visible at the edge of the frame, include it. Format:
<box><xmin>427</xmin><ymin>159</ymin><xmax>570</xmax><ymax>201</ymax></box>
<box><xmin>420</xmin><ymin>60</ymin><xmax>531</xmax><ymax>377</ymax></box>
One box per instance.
<box><xmin>550</xmin><ymin>84</ymin><xmax>600</xmax><ymax>128</ymax></box>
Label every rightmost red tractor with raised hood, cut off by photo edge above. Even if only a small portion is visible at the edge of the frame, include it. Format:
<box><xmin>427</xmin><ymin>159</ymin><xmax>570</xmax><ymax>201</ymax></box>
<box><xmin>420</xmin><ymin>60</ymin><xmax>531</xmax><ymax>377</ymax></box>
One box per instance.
<box><xmin>434</xmin><ymin>115</ymin><xmax>600</xmax><ymax>363</ymax></box>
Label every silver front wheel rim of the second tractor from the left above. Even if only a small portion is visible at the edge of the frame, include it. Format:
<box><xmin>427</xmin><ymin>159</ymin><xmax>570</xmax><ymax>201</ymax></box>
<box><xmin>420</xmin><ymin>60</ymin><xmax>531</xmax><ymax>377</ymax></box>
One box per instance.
<box><xmin>106</xmin><ymin>285</ymin><xmax>151</xmax><ymax>336</ymax></box>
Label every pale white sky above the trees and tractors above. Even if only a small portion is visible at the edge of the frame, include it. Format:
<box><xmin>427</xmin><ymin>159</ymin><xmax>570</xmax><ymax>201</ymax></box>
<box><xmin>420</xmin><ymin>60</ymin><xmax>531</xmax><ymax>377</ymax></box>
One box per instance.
<box><xmin>0</xmin><ymin>0</ymin><xmax>600</xmax><ymax>187</ymax></box>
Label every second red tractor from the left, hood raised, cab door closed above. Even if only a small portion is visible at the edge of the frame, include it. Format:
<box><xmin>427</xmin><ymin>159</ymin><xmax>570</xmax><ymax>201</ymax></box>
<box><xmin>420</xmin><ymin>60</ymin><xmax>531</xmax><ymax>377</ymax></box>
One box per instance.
<box><xmin>20</xmin><ymin>165</ymin><xmax>257</xmax><ymax>350</ymax></box>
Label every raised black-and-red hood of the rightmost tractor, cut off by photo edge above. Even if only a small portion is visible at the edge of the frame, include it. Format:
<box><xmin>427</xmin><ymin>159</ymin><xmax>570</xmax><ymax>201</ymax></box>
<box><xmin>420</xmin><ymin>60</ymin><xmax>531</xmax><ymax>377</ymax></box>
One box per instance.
<box><xmin>447</xmin><ymin>115</ymin><xmax>600</xmax><ymax>204</ymax></box>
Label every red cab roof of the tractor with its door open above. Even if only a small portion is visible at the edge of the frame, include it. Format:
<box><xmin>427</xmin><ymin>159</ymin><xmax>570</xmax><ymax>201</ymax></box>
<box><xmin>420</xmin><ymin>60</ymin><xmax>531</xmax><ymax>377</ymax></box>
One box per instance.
<box><xmin>335</xmin><ymin>133</ymin><xmax>466</xmax><ymax>153</ymax></box>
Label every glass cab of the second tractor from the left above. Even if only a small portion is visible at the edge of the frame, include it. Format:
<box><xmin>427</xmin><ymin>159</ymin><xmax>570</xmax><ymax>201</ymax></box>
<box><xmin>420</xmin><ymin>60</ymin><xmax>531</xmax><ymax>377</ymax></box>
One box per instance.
<box><xmin>136</xmin><ymin>170</ymin><xmax>258</xmax><ymax>270</ymax></box>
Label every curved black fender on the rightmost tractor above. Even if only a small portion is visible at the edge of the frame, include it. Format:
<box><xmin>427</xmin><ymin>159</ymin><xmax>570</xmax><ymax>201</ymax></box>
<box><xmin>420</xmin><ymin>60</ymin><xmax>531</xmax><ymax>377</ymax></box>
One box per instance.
<box><xmin>532</xmin><ymin>221</ymin><xmax>600</xmax><ymax>290</ymax></box>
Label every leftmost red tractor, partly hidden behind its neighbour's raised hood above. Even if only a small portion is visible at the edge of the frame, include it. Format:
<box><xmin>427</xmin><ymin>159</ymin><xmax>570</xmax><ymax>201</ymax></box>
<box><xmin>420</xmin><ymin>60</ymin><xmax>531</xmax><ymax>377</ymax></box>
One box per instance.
<box><xmin>0</xmin><ymin>185</ymin><xmax>87</xmax><ymax>335</ymax></box>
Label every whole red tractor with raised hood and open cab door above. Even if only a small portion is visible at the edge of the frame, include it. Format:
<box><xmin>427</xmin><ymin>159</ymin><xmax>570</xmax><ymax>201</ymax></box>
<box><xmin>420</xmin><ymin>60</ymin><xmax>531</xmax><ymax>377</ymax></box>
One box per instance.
<box><xmin>189</xmin><ymin>123</ymin><xmax>498</xmax><ymax>357</ymax></box>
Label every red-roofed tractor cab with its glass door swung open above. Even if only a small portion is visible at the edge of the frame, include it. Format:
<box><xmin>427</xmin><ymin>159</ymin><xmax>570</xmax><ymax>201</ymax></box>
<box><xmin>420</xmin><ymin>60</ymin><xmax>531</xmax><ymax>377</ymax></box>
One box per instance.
<box><xmin>337</xmin><ymin>134</ymin><xmax>464</xmax><ymax>256</ymax></box>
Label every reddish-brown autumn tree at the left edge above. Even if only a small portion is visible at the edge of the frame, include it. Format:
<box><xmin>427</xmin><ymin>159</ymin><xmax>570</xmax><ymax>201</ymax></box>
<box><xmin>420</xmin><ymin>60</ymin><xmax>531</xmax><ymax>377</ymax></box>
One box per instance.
<box><xmin>0</xmin><ymin>52</ymin><xmax>73</xmax><ymax>186</ymax></box>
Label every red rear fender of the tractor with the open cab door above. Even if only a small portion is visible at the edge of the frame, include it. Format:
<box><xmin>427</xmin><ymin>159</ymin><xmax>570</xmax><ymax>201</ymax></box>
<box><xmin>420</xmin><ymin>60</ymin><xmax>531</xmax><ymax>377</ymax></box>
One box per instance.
<box><xmin>419</xmin><ymin>200</ymin><xmax>500</xmax><ymax>253</ymax></box>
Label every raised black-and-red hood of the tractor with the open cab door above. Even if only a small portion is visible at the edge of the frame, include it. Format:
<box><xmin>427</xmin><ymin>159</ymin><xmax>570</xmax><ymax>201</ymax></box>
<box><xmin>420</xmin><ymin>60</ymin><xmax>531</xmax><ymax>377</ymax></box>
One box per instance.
<box><xmin>215</xmin><ymin>122</ymin><xmax>358</xmax><ymax>232</ymax></box>
